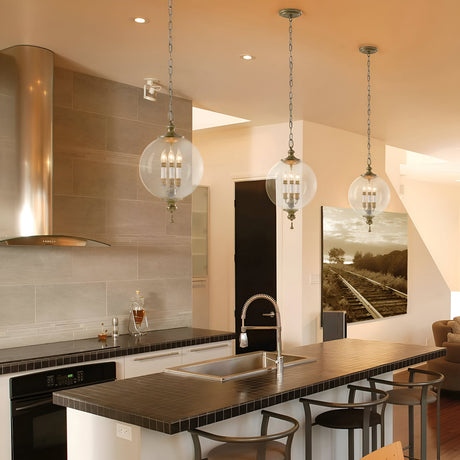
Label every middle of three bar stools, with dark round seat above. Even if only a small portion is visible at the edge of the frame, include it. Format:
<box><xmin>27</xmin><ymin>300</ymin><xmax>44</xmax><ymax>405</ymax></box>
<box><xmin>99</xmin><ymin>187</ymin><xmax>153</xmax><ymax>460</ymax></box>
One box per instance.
<box><xmin>300</xmin><ymin>385</ymin><xmax>388</xmax><ymax>460</ymax></box>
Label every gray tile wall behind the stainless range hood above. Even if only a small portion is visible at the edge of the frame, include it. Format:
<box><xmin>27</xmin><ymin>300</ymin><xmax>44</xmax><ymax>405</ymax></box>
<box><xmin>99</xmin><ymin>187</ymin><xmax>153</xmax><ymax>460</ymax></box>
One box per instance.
<box><xmin>0</xmin><ymin>68</ymin><xmax>192</xmax><ymax>348</ymax></box>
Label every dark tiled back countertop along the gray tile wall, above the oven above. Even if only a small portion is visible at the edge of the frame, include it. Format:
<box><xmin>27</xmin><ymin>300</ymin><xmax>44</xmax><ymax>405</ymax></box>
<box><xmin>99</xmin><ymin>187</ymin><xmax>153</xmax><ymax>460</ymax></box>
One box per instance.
<box><xmin>0</xmin><ymin>327</ymin><xmax>235</xmax><ymax>374</ymax></box>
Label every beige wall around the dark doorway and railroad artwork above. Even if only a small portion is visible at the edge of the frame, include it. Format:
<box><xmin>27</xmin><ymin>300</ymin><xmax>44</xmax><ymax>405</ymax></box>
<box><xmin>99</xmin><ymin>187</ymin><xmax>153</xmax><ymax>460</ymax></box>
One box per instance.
<box><xmin>194</xmin><ymin>121</ymin><xmax>450</xmax><ymax>346</ymax></box>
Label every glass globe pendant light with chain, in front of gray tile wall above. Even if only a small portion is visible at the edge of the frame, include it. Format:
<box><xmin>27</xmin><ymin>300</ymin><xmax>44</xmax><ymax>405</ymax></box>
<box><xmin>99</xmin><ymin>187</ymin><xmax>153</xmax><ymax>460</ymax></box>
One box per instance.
<box><xmin>139</xmin><ymin>0</ymin><xmax>203</xmax><ymax>222</ymax></box>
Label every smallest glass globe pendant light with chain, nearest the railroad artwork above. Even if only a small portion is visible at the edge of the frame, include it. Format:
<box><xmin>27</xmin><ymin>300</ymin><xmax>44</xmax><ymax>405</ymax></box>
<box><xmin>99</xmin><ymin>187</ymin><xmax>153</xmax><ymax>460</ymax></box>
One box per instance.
<box><xmin>348</xmin><ymin>46</ymin><xmax>390</xmax><ymax>231</ymax></box>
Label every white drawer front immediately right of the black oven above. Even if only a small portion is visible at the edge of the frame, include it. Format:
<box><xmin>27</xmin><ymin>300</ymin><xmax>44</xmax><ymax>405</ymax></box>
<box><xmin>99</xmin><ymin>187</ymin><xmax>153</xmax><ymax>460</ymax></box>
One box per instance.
<box><xmin>125</xmin><ymin>348</ymin><xmax>182</xmax><ymax>379</ymax></box>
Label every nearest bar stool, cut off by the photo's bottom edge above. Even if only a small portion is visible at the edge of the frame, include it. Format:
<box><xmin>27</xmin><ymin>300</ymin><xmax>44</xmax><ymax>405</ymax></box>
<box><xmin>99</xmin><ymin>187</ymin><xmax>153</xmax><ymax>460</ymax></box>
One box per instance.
<box><xmin>189</xmin><ymin>410</ymin><xmax>299</xmax><ymax>460</ymax></box>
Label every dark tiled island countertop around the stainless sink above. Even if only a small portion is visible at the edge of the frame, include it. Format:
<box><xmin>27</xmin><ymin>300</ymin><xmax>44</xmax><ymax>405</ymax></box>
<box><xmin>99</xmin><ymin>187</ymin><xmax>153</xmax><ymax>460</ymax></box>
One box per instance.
<box><xmin>53</xmin><ymin>339</ymin><xmax>446</xmax><ymax>434</ymax></box>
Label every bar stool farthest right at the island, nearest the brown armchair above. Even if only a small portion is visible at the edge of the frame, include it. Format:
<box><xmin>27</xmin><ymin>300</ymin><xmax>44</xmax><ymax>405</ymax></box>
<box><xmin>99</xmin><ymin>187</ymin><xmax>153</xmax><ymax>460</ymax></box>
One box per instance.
<box><xmin>369</xmin><ymin>368</ymin><xmax>444</xmax><ymax>460</ymax></box>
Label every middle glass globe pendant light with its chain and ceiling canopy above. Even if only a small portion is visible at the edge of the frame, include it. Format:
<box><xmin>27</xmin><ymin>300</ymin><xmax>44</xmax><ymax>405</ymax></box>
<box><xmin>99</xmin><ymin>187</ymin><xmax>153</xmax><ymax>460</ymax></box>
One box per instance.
<box><xmin>265</xmin><ymin>8</ymin><xmax>316</xmax><ymax>229</ymax></box>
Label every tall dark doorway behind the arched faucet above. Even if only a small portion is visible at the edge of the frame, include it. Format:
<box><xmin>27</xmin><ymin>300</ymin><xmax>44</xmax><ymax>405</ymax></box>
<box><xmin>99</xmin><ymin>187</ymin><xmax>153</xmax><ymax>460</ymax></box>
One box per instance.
<box><xmin>235</xmin><ymin>180</ymin><xmax>276</xmax><ymax>353</ymax></box>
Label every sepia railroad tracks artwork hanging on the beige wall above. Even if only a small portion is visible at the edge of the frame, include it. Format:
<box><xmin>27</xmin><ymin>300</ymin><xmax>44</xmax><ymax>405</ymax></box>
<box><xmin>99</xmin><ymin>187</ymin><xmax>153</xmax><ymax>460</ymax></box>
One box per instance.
<box><xmin>321</xmin><ymin>206</ymin><xmax>407</xmax><ymax>323</ymax></box>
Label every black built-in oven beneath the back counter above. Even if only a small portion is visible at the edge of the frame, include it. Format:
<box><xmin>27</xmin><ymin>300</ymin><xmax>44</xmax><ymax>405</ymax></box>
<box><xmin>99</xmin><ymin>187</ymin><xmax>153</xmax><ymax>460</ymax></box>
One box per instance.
<box><xmin>10</xmin><ymin>362</ymin><xmax>116</xmax><ymax>460</ymax></box>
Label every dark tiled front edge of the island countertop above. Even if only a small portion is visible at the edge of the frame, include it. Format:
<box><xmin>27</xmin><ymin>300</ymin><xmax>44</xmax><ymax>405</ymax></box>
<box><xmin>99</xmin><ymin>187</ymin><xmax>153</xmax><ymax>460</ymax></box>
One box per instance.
<box><xmin>53</xmin><ymin>348</ymin><xmax>446</xmax><ymax>435</ymax></box>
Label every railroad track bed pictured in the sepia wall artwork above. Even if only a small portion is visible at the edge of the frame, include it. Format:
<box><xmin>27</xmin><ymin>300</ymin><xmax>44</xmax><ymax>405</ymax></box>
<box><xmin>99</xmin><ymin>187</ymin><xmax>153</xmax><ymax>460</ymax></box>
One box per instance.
<box><xmin>329</xmin><ymin>268</ymin><xmax>407</xmax><ymax>321</ymax></box>
